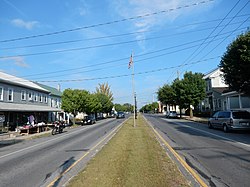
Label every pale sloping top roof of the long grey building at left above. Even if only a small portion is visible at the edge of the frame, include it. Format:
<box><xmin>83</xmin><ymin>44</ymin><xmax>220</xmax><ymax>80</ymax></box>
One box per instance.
<box><xmin>0</xmin><ymin>71</ymin><xmax>49</xmax><ymax>93</ymax></box>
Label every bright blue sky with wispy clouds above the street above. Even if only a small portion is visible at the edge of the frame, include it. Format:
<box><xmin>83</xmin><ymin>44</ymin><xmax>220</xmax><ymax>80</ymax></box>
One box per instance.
<box><xmin>0</xmin><ymin>0</ymin><xmax>250</xmax><ymax>108</ymax></box>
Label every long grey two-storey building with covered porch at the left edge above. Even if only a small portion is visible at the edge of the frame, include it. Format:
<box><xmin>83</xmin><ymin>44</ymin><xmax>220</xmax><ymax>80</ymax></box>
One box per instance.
<box><xmin>0</xmin><ymin>72</ymin><xmax>62</xmax><ymax>131</ymax></box>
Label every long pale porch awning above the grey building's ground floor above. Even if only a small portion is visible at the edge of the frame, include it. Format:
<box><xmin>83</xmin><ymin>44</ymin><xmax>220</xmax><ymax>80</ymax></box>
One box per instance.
<box><xmin>0</xmin><ymin>102</ymin><xmax>62</xmax><ymax>112</ymax></box>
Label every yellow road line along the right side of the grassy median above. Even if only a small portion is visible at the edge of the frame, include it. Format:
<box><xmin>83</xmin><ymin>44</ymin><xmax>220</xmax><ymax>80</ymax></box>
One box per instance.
<box><xmin>144</xmin><ymin>117</ymin><xmax>208</xmax><ymax>187</ymax></box>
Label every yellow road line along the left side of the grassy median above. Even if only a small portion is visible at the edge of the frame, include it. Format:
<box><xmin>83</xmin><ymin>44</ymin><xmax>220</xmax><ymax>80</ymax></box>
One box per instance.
<box><xmin>47</xmin><ymin>119</ymin><xmax>128</xmax><ymax>187</ymax></box>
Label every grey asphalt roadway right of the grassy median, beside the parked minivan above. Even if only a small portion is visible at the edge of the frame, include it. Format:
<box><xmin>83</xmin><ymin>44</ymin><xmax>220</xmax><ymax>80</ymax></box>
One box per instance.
<box><xmin>145</xmin><ymin>115</ymin><xmax>250</xmax><ymax>187</ymax></box>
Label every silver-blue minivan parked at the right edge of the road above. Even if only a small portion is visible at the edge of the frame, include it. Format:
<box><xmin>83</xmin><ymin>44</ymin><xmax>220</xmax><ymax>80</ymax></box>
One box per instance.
<box><xmin>208</xmin><ymin>110</ymin><xmax>250</xmax><ymax>132</ymax></box>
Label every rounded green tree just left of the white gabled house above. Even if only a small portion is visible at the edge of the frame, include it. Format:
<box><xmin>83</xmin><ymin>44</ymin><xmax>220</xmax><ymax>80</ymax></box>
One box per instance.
<box><xmin>182</xmin><ymin>71</ymin><xmax>206</xmax><ymax>118</ymax></box>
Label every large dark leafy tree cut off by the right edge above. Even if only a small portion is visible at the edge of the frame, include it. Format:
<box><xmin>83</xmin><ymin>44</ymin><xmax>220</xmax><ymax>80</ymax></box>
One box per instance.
<box><xmin>219</xmin><ymin>31</ymin><xmax>250</xmax><ymax>95</ymax></box>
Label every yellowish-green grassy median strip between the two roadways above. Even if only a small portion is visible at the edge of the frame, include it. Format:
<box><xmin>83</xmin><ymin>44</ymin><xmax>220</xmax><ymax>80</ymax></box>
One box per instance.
<box><xmin>69</xmin><ymin>116</ymin><xmax>189</xmax><ymax>187</ymax></box>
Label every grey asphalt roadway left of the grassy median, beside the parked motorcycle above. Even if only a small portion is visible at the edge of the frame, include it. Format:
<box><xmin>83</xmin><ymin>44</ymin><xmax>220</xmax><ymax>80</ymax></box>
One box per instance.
<box><xmin>0</xmin><ymin>118</ymin><xmax>125</xmax><ymax>187</ymax></box>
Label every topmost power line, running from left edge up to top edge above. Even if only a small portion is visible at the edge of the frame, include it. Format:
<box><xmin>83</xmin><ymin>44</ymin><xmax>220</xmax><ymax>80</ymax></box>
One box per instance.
<box><xmin>0</xmin><ymin>0</ymin><xmax>214</xmax><ymax>43</ymax></box>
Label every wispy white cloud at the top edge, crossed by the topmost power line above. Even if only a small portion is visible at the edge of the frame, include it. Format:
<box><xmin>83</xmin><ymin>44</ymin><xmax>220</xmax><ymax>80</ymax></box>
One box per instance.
<box><xmin>113</xmin><ymin>0</ymin><xmax>214</xmax><ymax>30</ymax></box>
